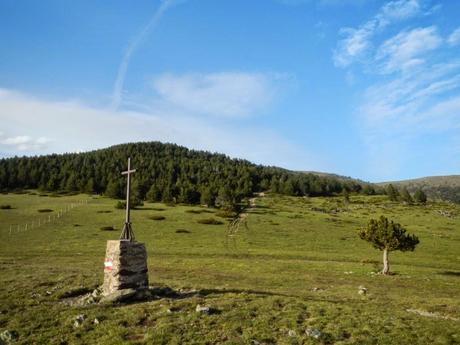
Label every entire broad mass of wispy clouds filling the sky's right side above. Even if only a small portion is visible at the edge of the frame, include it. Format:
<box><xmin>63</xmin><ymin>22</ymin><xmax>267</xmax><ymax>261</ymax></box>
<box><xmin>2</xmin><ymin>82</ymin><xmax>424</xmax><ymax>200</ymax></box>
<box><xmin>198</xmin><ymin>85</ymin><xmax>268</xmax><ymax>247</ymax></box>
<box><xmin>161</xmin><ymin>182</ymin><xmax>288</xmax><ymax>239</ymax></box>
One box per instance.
<box><xmin>333</xmin><ymin>0</ymin><xmax>460</xmax><ymax>179</ymax></box>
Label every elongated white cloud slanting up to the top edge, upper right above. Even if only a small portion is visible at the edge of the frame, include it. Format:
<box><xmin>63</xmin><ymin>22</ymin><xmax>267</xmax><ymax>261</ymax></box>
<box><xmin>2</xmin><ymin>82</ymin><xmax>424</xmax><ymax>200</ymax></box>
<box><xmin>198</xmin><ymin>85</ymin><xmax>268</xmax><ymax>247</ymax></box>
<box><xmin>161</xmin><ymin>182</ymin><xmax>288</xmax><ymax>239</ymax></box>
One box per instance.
<box><xmin>333</xmin><ymin>0</ymin><xmax>422</xmax><ymax>67</ymax></box>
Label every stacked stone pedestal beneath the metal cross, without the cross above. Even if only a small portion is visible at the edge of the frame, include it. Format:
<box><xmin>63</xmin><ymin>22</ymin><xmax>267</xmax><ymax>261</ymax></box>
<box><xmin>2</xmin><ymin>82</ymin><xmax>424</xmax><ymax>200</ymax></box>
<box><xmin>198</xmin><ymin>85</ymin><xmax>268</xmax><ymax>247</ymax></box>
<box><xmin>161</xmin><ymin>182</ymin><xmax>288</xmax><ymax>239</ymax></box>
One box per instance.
<box><xmin>102</xmin><ymin>240</ymin><xmax>149</xmax><ymax>296</ymax></box>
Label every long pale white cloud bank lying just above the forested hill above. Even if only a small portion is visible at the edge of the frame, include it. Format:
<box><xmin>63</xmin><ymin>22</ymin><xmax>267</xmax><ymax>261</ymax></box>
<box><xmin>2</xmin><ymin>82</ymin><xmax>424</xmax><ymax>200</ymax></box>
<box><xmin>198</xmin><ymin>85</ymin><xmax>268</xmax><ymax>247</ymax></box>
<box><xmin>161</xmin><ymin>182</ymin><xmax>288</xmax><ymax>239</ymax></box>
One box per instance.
<box><xmin>0</xmin><ymin>89</ymin><xmax>314</xmax><ymax>169</ymax></box>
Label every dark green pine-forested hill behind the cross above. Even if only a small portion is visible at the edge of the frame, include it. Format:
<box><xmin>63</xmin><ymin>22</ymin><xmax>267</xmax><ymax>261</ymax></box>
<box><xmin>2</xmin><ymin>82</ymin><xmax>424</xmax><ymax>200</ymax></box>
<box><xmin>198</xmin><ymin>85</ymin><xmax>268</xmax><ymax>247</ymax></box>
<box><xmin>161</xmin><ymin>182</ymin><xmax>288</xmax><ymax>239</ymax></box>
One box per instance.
<box><xmin>0</xmin><ymin>142</ymin><xmax>374</xmax><ymax>206</ymax></box>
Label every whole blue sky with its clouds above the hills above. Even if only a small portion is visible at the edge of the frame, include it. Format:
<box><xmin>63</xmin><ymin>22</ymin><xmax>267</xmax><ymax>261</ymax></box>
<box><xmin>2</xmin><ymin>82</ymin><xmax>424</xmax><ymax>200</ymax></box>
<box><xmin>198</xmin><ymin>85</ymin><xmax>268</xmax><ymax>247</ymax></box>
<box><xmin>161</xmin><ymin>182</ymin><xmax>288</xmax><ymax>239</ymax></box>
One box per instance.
<box><xmin>0</xmin><ymin>0</ymin><xmax>460</xmax><ymax>181</ymax></box>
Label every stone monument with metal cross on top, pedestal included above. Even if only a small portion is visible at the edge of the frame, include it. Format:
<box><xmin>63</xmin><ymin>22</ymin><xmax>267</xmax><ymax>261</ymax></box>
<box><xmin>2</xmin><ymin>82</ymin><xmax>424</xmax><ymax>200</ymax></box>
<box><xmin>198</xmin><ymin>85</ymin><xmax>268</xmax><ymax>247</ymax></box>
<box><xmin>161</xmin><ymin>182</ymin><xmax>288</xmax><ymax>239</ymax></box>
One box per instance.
<box><xmin>102</xmin><ymin>158</ymin><xmax>149</xmax><ymax>296</ymax></box>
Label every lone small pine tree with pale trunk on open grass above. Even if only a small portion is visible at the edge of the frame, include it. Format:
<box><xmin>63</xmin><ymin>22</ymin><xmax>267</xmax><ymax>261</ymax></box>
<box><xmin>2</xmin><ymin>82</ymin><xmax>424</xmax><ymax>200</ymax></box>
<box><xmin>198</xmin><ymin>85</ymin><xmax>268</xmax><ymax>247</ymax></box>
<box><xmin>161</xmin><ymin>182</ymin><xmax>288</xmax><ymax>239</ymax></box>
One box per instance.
<box><xmin>358</xmin><ymin>216</ymin><xmax>419</xmax><ymax>274</ymax></box>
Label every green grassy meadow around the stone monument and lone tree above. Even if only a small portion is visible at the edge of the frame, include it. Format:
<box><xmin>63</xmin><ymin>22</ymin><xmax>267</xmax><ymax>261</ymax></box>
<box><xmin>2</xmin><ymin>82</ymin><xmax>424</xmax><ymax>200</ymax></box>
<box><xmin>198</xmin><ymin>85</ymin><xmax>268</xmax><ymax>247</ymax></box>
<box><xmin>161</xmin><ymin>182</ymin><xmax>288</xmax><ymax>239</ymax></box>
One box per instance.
<box><xmin>0</xmin><ymin>194</ymin><xmax>460</xmax><ymax>344</ymax></box>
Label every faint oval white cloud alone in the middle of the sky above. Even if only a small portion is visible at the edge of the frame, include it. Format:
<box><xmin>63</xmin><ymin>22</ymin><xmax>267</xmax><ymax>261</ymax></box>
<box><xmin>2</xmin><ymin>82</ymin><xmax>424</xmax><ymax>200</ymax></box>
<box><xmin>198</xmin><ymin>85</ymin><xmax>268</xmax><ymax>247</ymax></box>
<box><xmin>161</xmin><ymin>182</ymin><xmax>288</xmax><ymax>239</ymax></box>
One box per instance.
<box><xmin>153</xmin><ymin>72</ymin><xmax>273</xmax><ymax>117</ymax></box>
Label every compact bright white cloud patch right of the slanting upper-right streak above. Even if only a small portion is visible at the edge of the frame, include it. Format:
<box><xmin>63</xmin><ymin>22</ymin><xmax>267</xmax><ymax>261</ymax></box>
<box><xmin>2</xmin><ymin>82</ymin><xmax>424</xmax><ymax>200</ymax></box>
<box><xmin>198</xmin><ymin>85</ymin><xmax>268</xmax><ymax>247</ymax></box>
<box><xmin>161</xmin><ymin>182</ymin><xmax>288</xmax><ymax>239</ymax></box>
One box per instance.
<box><xmin>376</xmin><ymin>26</ymin><xmax>442</xmax><ymax>73</ymax></box>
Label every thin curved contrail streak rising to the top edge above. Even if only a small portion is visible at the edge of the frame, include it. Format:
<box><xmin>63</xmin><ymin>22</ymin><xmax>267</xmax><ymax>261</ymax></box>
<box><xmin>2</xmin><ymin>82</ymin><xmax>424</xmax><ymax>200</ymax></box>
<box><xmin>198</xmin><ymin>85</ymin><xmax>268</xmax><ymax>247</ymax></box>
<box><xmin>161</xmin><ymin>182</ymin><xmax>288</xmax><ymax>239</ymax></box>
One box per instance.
<box><xmin>111</xmin><ymin>0</ymin><xmax>174</xmax><ymax>110</ymax></box>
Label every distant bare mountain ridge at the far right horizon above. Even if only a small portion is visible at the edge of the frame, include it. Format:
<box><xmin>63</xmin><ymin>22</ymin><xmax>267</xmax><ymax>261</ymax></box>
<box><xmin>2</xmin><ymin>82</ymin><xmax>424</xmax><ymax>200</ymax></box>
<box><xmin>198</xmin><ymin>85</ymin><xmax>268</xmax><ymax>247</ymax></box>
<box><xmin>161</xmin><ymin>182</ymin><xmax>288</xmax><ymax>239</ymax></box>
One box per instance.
<box><xmin>377</xmin><ymin>175</ymin><xmax>460</xmax><ymax>203</ymax></box>
